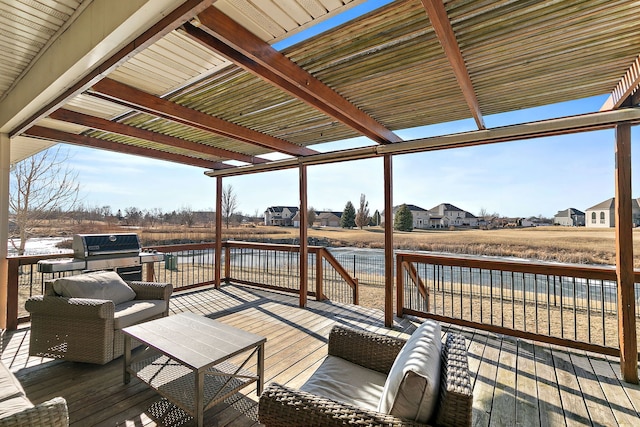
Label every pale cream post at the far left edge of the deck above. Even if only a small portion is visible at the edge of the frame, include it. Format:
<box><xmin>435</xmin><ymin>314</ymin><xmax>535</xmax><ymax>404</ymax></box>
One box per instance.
<box><xmin>0</xmin><ymin>133</ymin><xmax>9</xmax><ymax>330</ymax></box>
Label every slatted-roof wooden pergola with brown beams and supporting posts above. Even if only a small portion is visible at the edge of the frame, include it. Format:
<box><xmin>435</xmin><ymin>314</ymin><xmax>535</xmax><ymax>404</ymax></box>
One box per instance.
<box><xmin>0</xmin><ymin>0</ymin><xmax>640</xmax><ymax>382</ymax></box>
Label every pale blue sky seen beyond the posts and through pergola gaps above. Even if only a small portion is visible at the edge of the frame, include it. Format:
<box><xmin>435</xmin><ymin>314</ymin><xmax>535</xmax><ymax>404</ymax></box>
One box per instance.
<box><xmin>61</xmin><ymin>1</ymin><xmax>640</xmax><ymax>217</ymax></box>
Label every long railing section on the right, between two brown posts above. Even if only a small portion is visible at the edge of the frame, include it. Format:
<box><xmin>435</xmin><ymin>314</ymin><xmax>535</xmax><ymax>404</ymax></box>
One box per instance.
<box><xmin>396</xmin><ymin>253</ymin><xmax>640</xmax><ymax>355</ymax></box>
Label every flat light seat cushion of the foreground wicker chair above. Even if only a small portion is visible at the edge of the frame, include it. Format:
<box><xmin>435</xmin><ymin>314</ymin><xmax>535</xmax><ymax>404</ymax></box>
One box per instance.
<box><xmin>300</xmin><ymin>356</ymin><xmax>386</xmax><ymax>411</ymax></box>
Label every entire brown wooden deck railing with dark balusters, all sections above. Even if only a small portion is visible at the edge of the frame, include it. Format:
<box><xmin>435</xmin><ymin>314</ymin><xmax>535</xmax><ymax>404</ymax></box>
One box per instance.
<box><xmin>8</xmin><ymin>241</ymin><xmax>640</xmax><ymax>355</ymax></box>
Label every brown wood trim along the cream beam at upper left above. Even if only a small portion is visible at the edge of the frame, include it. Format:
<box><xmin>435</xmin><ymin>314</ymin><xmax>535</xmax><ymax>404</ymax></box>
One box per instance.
<box><xmin>10</xmin><ymin>0</ymin><xmax>215</xmax><ymax>137</ymax></box>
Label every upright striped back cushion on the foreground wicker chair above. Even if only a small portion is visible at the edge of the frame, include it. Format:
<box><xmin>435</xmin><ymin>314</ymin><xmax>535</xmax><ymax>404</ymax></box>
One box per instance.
<box><xmin>378</xmin><ymin>320</ymin><xmax>442</xmax><ymax>423</ymax></box>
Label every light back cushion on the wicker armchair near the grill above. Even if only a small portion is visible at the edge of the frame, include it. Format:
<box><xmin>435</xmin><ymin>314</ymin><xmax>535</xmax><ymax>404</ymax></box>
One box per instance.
<box><xmin>53</xmin><ymin>271</ymin><xmax>136</xmax><ymax>305</ymax></box>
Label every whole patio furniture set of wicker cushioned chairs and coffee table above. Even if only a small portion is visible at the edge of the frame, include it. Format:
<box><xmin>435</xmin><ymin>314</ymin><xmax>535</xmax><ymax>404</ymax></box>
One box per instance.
<box><xmin>5</xmin><ymin>272</ymin><xmax>473</xmax><ymax>426</ymax></box>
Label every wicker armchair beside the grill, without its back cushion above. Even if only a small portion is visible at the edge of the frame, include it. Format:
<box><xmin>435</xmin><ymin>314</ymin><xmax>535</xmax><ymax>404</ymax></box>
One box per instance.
<box><xmin>25</xmin><ymin>280</ymin><xmax>173</xmax><ymax>364</ymax></box>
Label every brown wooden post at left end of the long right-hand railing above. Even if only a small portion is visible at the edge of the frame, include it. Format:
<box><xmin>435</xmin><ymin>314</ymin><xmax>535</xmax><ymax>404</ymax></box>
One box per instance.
<box><xmin>384</xmin><ymin>154</ymin><xmax>393</xmax><ymax>328</ymax></box>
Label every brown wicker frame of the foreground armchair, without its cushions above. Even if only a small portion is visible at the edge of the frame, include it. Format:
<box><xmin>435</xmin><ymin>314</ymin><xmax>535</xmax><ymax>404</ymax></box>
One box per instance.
<box><xmin>258</xmin><ymin>326</ymin><xmax>473</xmax><ymax>427</ymax></box>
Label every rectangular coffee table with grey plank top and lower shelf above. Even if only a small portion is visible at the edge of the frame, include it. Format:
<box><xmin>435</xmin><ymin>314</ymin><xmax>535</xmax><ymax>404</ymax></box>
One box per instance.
<box><xmin>122</xmin><ymin>313</ymin><xmax>267</xmax><ymax>426</ymax></box>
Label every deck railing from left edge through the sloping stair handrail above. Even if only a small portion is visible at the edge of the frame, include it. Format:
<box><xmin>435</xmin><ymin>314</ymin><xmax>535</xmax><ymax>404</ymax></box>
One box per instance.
<box><xmin>7</xmin><ymin>242</ymin><xmax>358</xmax><ymax>329</ymax></box>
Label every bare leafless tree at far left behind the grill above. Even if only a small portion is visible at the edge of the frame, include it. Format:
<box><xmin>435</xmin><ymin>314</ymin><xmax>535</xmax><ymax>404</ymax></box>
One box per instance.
<box><xmin>9</xmin><ymin>146</ymin><xmax>80</xmax><ymax>255</ymax></box>
